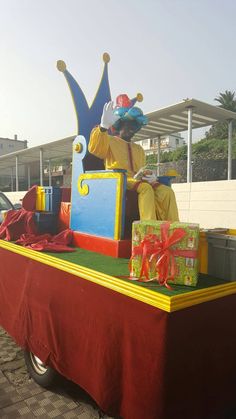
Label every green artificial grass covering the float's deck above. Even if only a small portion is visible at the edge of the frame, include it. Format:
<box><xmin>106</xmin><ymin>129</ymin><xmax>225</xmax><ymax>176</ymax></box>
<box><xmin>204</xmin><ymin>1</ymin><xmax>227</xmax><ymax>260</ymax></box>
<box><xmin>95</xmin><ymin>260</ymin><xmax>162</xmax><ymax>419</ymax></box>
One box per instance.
<box><xmin>53</xmin><ymin>248</ymin><xmax>229</xmax><ymax>296</ymax></box>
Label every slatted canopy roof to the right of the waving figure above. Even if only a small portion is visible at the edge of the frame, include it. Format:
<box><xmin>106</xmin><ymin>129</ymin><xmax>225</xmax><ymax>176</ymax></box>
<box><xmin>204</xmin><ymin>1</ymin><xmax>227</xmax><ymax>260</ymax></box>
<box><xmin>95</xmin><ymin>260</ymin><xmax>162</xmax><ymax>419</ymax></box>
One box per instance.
<box><xmin>133</xmin><ymin>99</ymin><xmax>236</xmax><ymax>141</ymax></box>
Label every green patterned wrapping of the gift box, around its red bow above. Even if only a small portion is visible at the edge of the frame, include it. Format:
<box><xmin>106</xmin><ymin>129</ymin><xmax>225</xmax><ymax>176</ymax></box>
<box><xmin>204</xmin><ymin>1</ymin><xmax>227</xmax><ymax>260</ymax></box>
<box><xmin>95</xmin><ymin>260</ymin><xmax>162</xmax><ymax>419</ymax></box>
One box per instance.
<box><xmin>131</xmin><ymin>221</ymin><xmax>199</xmax><ymax>286</ymax></box>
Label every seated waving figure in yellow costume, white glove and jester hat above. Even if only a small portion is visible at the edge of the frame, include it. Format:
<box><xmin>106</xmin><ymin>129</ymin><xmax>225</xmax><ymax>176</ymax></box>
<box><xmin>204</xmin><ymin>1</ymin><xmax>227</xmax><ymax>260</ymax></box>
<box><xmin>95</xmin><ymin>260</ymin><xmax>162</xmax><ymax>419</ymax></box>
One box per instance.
<box><xmin>88</xmin><ymin>94</ymin><xmax>179</xmax><ymax>221</ymax></box>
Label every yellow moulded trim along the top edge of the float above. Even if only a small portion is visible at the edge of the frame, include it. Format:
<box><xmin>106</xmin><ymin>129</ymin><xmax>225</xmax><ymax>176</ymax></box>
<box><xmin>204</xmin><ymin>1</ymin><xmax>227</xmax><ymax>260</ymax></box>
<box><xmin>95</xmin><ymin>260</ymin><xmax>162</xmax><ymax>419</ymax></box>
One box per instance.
<box><xmin>0</xmin><ymin>240</ymin><xmax>236</xmax><ymax>313</ymax></box>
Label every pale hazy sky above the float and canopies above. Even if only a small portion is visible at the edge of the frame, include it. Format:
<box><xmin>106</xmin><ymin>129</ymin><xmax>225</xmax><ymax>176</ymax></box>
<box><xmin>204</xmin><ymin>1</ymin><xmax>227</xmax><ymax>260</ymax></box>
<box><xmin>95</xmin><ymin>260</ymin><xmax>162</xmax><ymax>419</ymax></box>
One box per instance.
<box><xmin>0</xmin><ymin>0</ymin><xmax>236</xmax><ymax>147</ymax></box>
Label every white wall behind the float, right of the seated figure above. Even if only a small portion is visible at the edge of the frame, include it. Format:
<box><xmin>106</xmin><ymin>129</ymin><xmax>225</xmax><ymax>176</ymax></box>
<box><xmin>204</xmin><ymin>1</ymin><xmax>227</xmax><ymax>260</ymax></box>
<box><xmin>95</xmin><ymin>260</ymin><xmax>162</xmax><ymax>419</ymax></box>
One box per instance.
<box><xmin>172</xmin><ymin>180</ymin><xmax>236</xmax><ymax>229</ymax></box>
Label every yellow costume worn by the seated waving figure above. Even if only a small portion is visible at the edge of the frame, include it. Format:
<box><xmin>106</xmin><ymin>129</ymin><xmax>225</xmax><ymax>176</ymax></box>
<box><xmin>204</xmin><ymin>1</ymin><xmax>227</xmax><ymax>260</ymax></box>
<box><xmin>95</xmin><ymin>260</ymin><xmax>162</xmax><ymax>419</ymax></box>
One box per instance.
<box><xmin>88</xmin><ymin>126</ymin><xmax>179</xmax><ymax>221</ymax></box>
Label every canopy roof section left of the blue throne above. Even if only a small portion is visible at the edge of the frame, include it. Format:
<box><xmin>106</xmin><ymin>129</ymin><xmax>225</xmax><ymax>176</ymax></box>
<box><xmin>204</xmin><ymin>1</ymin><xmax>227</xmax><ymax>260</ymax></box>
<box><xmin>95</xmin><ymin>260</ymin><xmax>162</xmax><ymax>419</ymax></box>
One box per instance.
<box><xmin>0</xmin><ymin>136</ymin><xmax>75</xmax><ymax>172</ymax></box>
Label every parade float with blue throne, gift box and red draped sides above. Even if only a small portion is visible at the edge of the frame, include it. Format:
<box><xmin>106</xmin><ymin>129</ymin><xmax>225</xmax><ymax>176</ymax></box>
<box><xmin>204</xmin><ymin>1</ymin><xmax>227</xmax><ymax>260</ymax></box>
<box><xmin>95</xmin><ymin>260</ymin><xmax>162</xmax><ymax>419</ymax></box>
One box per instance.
<box><xmin>0</xmin><ymin>54</ymin><xmax>236</xmax><ymax>419</ymax></box>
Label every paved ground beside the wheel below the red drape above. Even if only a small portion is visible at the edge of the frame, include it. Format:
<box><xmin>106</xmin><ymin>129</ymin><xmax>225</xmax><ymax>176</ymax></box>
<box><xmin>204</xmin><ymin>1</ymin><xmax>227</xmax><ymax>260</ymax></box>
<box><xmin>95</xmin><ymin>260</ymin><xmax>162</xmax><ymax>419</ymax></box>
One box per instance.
<box><xmin>0</xmin><ymin>328</ymin><xmax>115</xmax><ymax>419</ymax></box>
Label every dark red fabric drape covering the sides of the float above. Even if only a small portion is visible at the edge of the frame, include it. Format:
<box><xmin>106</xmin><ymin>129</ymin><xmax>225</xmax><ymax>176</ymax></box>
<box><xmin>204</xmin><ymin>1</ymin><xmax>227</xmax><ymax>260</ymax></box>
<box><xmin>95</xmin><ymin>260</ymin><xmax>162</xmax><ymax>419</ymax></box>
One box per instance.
<box><xmin>0</xmin><ymin>248</ymin><xmax>236</xmax><ymax>419</ymax></box>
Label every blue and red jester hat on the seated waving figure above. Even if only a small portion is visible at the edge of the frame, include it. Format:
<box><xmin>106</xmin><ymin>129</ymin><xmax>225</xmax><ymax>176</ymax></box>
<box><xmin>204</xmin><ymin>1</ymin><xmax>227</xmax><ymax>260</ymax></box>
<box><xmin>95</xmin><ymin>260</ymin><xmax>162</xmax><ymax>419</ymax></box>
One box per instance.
<box><xmin>112</xmin><ymin>93</ymin><xmax>148</xmax><ymax>132</ymax></box>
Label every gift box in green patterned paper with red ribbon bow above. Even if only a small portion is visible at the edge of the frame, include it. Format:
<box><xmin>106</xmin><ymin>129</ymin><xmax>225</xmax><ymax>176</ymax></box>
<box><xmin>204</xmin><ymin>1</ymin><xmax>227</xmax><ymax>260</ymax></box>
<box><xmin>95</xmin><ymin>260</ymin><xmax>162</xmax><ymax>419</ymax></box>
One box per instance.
<box><xmin>130</xmin><ymin>221</ymin><xmax>199</xmax><ymax>286</ymax></box>
